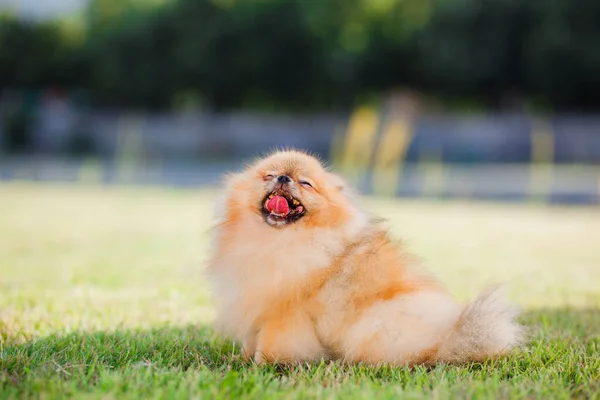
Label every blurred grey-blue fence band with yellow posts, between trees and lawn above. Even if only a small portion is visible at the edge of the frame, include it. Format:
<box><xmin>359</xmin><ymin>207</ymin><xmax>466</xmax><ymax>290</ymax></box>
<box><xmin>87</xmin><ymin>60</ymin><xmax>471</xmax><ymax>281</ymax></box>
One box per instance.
<box><xmin>0</xmin><ymin>106</ymin><xmax>600</xmax><ymax>203</ymax></box>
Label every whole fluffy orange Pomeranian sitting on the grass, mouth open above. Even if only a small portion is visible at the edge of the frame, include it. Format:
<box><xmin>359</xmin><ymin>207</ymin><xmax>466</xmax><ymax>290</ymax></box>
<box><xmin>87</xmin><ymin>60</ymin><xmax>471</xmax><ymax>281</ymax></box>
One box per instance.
<box><xmin>208</xmin><ymin>150</ymin><xmax>523</xmax><ymax>365</ymax></box>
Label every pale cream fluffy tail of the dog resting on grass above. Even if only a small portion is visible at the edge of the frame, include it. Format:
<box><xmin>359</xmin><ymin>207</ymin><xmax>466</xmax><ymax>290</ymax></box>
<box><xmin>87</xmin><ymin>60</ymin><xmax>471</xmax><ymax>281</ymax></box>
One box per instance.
<box><xmin>436</xmin><ymin>288</ymin><xmax>526</xmax><ymax>363</ymax></box>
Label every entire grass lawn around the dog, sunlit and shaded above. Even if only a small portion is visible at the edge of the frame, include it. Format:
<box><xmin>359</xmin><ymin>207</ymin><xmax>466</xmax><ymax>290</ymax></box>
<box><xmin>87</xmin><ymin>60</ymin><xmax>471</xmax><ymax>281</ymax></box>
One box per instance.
<box><xmin>0</xmin><ymin>184</ymin><xmax>600</xmax><ymax>399</ymax></box>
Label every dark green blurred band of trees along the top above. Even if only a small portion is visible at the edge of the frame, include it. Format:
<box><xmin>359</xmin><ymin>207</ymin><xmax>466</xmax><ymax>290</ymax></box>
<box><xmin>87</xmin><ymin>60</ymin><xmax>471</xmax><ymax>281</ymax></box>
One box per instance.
<box><xmin>0</xmin><ymin>0</ymin><xmax>600</xmax><ymax>110</ymax></box>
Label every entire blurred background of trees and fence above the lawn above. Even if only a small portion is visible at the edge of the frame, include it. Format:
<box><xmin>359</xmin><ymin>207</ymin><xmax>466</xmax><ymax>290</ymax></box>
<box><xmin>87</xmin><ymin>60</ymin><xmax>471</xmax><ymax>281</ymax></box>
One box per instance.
<box><xmin>0</xmin><ymin>0</ymin><xmax>600</xmax><ymax>204</ymax></box>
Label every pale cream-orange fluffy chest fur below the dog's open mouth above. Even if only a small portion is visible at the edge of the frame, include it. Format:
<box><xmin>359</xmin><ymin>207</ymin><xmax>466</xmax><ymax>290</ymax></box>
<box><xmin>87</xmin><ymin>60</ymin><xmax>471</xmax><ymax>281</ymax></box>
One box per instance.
<box><xmin>209</xmin><ymin>217</ymin><xmax>348</xmax><ymax>340</ymax></box>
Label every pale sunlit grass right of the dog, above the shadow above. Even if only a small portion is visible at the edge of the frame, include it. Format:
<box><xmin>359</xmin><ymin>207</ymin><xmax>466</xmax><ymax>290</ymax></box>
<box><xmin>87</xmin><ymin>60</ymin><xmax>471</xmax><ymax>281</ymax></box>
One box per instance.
<box><xmin>360</xmin><ymin>199</ymin><xmax>600</xmax><ymax>308</ymax></box>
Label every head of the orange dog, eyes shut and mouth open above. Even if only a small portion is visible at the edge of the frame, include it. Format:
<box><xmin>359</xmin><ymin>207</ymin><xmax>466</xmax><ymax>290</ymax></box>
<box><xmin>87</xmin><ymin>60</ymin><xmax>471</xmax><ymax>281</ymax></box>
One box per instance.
<box><xmin>223</xmin><ymin>151</ymin><xmax>356</xmax><ymax>229</ymax></box>
